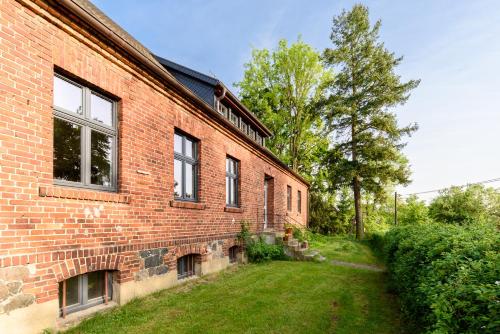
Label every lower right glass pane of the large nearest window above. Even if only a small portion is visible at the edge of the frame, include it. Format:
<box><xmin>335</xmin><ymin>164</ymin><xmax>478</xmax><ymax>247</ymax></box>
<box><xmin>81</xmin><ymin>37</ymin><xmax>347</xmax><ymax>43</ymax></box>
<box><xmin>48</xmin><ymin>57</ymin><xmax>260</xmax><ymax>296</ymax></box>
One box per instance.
<box><xmin>90</xmin><ymin>131</ymin><xmax>113</xmax><ymax>187</ymax></box>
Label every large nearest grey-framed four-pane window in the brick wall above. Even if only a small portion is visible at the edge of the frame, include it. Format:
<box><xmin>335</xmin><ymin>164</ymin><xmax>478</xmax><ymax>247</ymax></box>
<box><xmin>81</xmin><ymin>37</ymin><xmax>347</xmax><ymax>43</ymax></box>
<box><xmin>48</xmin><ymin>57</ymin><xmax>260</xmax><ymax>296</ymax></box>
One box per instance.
<box><xmin>53</xmin><ymin>75</ymin><xmax>117</xmax><ymax>190</ymax></box>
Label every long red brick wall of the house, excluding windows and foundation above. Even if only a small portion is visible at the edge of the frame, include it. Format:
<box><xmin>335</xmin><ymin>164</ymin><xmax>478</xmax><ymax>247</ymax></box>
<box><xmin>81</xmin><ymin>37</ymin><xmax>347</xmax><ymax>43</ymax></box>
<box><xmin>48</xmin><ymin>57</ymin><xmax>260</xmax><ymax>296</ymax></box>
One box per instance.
<box><xmin>0</xmin><ymin>0</ymin><xmax>307</xmax><ymax>302</ymax></box>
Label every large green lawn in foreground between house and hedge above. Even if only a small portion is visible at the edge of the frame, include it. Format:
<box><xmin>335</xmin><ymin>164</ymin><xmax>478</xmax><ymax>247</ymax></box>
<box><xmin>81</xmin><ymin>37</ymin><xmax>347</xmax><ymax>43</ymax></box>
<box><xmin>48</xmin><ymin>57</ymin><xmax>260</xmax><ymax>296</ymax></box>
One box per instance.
<box><xmin>63</xmin><ymin>237</ymin><xmax>404</xmax><ymax>334</ymax></box>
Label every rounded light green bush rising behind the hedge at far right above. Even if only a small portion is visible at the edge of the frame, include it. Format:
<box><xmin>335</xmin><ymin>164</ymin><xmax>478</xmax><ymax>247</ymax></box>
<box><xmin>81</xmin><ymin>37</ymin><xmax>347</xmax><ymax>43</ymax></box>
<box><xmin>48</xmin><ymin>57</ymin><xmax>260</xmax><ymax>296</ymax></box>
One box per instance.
<box><xmin>429</xmin><ymin>185</ymin><xmax>500</xmax><ymax>225</ymax></box>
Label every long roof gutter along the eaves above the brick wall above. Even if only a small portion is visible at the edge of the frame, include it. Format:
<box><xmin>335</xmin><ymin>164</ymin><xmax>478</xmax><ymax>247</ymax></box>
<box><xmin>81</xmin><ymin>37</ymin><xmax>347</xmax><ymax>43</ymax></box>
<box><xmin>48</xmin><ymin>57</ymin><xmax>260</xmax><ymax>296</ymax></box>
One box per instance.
<box><xmin>51</xmin><ymin>0</ymin><xmax>310</xmax><ymax>187</ymax></box>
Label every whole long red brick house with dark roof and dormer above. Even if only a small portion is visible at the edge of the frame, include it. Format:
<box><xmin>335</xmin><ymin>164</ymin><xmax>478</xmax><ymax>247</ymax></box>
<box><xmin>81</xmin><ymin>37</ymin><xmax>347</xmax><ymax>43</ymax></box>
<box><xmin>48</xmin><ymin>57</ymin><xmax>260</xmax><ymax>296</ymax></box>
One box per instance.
<box><xmin>0</xmin><ymin>0</ymin><xmax>308</xmax><ymax>333</ymax></box>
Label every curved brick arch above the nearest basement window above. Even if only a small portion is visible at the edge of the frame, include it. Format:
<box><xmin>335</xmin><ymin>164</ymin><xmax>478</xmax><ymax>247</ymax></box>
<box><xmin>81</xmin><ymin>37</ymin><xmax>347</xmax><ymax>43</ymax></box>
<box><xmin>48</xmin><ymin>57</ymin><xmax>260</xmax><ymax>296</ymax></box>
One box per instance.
<box><xmin>51</xmin><ymin>254</ymin><xmax>124</xmax><ymax>282</ymax></box>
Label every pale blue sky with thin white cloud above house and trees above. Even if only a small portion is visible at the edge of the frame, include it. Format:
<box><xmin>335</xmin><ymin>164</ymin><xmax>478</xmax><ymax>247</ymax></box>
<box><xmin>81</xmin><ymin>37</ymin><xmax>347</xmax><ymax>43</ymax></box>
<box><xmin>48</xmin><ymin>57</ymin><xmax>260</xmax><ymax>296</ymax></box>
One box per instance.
<box><xmin>93</xmin><ymin>0</ymin><xmax>500</xmax><ymax>198</ymax></box>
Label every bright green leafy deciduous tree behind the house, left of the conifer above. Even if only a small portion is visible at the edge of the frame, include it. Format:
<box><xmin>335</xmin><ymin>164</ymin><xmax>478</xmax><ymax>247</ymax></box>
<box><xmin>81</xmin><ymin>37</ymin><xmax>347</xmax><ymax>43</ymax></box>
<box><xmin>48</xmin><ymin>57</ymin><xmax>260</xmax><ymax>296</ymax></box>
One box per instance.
<box><xmin>235</xmin><ymin>38</ymin><xmax>331</xmax><ymax>179</ymax></box>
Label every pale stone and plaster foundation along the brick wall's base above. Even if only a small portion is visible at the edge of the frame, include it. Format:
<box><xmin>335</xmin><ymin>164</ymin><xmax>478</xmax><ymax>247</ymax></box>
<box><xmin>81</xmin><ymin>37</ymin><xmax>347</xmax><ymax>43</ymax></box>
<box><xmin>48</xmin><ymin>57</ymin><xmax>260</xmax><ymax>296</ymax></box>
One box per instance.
<box><xmin>0</xmin><ymin>239</ymin><xmax>245</xmax><ymax>334</ymax></box>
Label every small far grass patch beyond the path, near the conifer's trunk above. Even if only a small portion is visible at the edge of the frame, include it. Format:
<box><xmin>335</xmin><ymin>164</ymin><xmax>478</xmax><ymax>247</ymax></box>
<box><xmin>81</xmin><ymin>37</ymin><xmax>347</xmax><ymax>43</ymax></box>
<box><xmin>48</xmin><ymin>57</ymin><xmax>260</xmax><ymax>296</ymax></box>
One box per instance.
<box><xmin>310</xmin><ymin>235</ymin><xmax>382</xmax><ymax>265</ymax></box>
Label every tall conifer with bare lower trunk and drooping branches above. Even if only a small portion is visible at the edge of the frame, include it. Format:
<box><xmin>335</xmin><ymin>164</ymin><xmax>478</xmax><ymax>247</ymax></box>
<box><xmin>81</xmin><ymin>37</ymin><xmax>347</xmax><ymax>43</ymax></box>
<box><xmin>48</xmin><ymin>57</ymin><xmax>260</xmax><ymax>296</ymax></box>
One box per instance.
<box><xmin>323</xmin><ymin>5</ymin><xmax>419</xmax><ymax>239</ymax></box>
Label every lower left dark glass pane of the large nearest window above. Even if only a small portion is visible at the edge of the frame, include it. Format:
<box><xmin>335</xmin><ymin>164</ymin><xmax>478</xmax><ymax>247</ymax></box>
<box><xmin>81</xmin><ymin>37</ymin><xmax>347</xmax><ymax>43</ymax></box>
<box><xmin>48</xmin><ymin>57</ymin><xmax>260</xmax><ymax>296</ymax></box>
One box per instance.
<box><xmin>53</xmin><ymin>118</ymin><xmax>81</xmax><ymax>182</ymax></box>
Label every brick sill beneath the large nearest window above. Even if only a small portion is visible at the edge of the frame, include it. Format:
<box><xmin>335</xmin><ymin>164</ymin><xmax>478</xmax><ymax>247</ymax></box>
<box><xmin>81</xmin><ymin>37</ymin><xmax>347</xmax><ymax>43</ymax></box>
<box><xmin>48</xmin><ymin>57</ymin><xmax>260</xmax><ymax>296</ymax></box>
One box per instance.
<box><xmin>38</xmin><ymin>186</ymin><xmax>130</xmax><ymax>204</ymax></box>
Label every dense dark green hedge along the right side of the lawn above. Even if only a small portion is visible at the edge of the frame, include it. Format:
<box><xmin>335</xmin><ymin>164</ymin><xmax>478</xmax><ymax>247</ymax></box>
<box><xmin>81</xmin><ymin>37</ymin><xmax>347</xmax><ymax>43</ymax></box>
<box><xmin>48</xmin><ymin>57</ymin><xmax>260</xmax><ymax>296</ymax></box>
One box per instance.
<box><xmin>384</xmin><ymin>224</ymin><xmax>500</xmax><ymax>333</ymax></box>
